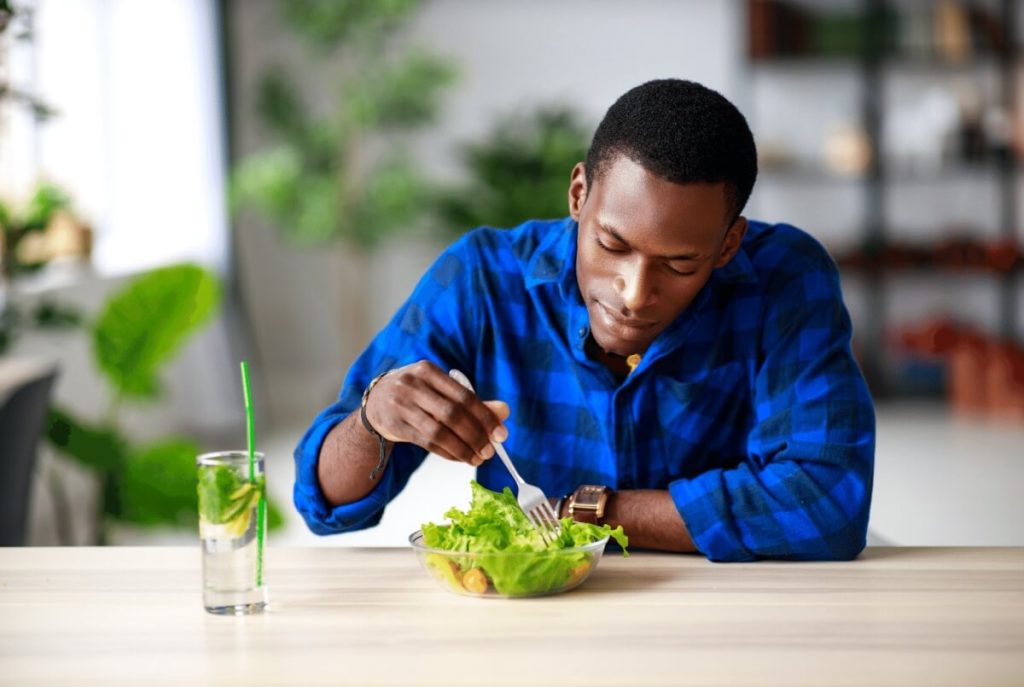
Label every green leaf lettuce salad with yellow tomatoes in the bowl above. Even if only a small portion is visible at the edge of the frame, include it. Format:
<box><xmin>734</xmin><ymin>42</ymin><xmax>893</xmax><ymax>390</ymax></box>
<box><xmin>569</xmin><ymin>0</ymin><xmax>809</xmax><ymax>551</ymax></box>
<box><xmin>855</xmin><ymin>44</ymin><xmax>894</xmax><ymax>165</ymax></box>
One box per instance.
<box><xmin>422</xmin><ymin>481</ymin><xmax>629</xmax><ymax>596</ymax></box>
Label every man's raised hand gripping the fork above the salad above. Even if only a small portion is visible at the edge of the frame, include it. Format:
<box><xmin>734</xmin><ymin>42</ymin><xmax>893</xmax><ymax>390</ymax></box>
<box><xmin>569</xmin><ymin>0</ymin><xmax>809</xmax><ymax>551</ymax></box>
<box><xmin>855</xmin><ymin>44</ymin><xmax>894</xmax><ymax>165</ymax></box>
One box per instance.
<box><xmin>367</xmin><ymin>360</ymin><xmax>509</xmax><ymax>466</ymax></box>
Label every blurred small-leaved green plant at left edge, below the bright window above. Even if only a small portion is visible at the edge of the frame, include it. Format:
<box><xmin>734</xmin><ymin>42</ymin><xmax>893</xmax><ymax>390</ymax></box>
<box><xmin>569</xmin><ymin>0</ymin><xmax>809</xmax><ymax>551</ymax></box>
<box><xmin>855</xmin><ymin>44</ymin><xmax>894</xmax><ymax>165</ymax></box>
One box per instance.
<box><xmin>0</xmin><ymin>183</ymin><xmax>82</xmax><ymax>355</ymax></box>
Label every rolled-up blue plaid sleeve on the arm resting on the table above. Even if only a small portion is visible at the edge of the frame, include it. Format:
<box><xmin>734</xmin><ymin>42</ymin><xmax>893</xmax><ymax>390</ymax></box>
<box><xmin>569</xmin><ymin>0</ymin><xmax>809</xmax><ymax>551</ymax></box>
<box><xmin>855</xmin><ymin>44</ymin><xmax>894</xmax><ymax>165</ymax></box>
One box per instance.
<box><xmin>669</xmin><ymin>243</ymin><xmax>874</xmax><ymax>561</ymax></box>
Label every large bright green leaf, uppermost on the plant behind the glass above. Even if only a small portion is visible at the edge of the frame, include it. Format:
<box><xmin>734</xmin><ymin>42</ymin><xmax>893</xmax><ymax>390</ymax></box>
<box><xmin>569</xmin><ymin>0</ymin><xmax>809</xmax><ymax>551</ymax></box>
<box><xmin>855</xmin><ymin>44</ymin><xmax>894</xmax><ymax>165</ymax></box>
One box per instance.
<box><xmin>92</xmin><ymin>264</ymin><xmax>220</xmax><ymax>398</ymax></box>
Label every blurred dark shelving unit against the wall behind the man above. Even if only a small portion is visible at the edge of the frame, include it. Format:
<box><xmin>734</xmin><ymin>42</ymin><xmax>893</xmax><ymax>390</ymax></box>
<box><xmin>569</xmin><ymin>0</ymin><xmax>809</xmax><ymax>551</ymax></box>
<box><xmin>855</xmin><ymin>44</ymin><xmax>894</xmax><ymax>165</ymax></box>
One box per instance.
<box><xmin>746</xmin><ymin>0</ymin><xmax>1024</xmax><ymax>397</ymax></box>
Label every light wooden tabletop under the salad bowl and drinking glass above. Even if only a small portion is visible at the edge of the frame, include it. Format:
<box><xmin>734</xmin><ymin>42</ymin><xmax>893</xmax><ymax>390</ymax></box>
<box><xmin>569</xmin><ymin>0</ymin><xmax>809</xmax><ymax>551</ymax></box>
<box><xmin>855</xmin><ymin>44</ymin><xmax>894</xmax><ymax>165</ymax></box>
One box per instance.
<box><xmin>0</xmin><ymin>547</ymin><xmax>1024</xmax><ymax>687</ymax></box>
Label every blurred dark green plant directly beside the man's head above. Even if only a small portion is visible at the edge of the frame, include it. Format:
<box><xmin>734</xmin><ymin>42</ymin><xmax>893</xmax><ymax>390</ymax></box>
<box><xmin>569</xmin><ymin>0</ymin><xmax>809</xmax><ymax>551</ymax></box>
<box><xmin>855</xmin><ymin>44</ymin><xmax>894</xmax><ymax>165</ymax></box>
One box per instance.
<box><xmin>437</xmin><ymin>106</ymin><xmax>589</xmax><ymax>234</ymax></box>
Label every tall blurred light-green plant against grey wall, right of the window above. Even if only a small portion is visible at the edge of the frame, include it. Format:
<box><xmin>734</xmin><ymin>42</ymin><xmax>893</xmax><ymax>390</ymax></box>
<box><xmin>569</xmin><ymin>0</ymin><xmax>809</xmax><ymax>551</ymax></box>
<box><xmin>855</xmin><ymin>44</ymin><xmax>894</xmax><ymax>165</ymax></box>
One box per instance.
<box><xmin>230</xmin><ymin>0</ymin><xmax>455</xmax><ymax>250</ymax></box>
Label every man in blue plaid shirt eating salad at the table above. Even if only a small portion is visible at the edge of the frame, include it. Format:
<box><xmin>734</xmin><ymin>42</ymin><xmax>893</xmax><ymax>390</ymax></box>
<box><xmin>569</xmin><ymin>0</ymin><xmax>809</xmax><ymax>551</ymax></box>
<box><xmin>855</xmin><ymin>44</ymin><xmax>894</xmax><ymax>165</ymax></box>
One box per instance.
<box><xmin>295</xmin><ymin>80</ymin><xmax>874</xmax><ymax>561</ymax></box>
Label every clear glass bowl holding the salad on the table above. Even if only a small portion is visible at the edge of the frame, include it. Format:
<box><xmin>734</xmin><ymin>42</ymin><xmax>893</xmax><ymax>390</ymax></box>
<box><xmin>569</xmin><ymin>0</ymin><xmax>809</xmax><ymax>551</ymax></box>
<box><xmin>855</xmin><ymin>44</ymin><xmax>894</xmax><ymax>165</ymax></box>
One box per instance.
<box><xmin>409</xmin><ymin>529</ymin><xmax>608</xmax><ymax>598</ymax></box>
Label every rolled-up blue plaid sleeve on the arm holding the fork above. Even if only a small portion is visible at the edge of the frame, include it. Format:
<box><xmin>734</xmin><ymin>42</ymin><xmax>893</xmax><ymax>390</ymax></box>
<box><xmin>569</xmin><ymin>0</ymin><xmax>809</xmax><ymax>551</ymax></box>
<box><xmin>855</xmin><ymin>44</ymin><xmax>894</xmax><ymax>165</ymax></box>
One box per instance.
<box><xmin>293</xmin><ymin>234</ymin><xmax>480</xmax><ymax>534</ymax></box>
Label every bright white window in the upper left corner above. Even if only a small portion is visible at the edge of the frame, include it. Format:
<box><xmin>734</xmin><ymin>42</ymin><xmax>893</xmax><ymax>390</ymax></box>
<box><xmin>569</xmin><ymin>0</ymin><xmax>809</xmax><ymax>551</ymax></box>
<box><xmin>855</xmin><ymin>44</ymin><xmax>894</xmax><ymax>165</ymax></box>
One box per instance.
<box><xmin>0</xmin><ymin>0</ymin><xmax>228</xmax><ymax>274</ymax></box>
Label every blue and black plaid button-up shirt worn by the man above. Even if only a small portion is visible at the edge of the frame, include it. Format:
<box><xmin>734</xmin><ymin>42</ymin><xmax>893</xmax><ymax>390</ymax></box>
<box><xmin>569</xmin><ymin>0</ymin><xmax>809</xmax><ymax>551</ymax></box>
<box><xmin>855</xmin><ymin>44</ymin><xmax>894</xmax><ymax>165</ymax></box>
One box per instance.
<box><xmin>294</xmin><ymin>218</ymin><xmax>874</xmax><ymax>561</ymax></box>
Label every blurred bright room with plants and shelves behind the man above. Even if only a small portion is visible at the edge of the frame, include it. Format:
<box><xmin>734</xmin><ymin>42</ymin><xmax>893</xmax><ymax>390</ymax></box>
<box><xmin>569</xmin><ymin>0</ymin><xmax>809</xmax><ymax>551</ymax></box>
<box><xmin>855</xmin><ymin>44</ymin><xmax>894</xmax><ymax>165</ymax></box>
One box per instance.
<box><xmin>0</xmin><ymin>0</ymin><xmax>1024</xmax><ymax>546</ymax></box>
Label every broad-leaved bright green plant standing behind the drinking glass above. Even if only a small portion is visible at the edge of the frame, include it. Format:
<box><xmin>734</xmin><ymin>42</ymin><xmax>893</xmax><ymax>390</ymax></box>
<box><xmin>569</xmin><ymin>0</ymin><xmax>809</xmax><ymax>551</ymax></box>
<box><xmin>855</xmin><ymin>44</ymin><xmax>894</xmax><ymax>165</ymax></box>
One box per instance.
<box><xmin>47</xmin><ymin>264</ymin><xmax>284</xmax><ymax>544</ymax></box>
